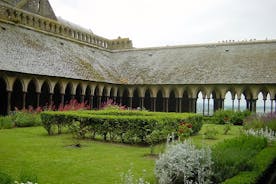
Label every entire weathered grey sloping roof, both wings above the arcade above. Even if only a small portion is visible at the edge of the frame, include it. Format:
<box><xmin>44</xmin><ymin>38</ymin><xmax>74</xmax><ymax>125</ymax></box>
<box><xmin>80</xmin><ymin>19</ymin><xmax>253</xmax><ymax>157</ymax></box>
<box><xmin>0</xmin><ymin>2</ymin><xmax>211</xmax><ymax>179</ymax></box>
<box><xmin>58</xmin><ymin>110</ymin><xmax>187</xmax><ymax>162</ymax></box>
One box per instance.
<box><xmin>0</xmin><ymin>23</ymin><xmax>276</xmax><ymax>84</ymax></box>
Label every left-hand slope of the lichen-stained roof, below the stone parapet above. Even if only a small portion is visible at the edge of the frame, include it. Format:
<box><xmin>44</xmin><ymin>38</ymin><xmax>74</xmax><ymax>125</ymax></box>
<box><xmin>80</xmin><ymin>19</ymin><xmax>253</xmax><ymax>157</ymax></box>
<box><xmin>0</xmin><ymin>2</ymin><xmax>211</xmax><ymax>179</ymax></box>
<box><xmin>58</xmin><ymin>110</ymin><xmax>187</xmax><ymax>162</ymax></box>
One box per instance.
<box><xmin>0</xmin><ymin>23</ymin><xmax>120</xmax><ymax>82</ymax></box>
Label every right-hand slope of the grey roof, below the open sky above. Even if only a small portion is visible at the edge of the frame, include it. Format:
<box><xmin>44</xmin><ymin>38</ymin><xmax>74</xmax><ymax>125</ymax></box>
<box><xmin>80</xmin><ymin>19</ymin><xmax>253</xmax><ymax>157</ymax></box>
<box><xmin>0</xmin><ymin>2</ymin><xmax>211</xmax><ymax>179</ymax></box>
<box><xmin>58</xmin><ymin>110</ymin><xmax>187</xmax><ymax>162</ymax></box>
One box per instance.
<box><xmin>113</xmin><ymin>41</ymin><xmax>276</xmax><ymax>84</ymax></box>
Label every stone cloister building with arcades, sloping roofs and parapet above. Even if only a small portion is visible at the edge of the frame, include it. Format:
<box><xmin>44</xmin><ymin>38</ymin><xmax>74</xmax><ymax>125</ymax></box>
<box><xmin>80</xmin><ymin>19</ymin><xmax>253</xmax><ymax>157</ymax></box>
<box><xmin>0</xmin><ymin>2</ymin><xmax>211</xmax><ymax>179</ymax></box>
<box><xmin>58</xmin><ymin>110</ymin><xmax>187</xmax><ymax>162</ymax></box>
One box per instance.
<box><xmin>0</xmin><ymin>0</ymin><xmax>276</xmax><ymax>115</ymax></box>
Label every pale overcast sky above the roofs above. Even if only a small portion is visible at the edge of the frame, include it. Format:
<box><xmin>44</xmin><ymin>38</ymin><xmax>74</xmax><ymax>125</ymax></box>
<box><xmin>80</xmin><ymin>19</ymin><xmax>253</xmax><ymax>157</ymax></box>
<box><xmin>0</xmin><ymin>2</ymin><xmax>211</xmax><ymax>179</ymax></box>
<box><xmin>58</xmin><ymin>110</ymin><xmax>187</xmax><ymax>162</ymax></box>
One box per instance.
<box><xmin>50</xmin><ymin>0</ymin><xmax>276</xmax><ymax>47</ymax></box>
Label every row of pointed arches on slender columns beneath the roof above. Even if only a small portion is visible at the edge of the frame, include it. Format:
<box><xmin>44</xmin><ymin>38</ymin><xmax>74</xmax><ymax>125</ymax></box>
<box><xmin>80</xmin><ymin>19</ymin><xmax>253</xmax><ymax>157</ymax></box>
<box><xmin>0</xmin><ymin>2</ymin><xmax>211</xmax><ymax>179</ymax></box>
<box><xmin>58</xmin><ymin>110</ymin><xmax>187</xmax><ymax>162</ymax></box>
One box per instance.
<box><xmin>0</xmin><ymin>72</ymin><xmax>276</xmax><ymax>115</ymax></box>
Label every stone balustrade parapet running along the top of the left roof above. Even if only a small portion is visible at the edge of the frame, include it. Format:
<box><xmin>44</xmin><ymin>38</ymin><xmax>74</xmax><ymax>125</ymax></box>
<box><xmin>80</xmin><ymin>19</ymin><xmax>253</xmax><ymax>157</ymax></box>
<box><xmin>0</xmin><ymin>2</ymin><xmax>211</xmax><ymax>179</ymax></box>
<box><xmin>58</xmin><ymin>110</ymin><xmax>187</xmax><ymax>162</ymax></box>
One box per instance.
<box><xmin>0</xmin><ymin>4</ymin><xmax>132</xmax><ymax>50</ymax></box>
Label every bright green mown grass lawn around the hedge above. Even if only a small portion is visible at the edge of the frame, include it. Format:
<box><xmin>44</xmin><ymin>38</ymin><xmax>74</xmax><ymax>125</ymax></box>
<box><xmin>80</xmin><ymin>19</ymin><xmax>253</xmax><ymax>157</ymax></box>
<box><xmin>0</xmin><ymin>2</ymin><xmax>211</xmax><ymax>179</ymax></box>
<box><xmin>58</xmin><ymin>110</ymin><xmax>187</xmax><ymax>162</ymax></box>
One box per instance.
<box><xmin>0</xmin><ymin>125</ymin><xmax>240</xmax><ymax>184</ymax></box>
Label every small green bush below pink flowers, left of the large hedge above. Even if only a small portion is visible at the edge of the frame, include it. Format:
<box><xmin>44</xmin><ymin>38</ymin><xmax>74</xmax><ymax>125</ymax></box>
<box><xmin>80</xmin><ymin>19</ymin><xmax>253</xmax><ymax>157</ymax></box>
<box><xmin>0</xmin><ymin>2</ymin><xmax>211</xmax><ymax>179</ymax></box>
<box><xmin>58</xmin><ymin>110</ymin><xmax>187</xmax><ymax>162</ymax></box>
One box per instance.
<box><xmin>12</xmin><ymin>111</ymin><xmax>41</xmax><ymax>127</ymax></box>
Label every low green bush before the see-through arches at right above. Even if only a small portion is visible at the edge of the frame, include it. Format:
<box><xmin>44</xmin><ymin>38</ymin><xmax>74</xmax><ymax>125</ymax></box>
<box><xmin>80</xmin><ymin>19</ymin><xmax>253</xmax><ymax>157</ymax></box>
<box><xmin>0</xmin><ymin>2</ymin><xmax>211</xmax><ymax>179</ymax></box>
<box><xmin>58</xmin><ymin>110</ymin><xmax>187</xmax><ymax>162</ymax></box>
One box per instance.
<box><xmin>213</xmin><ymin>110</ymin><xmax>250</xmax><ymax>125</ymax></box>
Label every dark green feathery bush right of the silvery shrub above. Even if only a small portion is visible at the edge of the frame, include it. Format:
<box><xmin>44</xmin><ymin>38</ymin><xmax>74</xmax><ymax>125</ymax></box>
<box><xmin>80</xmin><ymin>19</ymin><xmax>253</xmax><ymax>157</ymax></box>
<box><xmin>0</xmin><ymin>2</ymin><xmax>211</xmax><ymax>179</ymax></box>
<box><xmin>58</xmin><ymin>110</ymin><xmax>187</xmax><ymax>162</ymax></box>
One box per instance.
<box><xmin>212</xmin><ymin>136</ymin><xmax>267</xmax><ymax>183</ymax></box>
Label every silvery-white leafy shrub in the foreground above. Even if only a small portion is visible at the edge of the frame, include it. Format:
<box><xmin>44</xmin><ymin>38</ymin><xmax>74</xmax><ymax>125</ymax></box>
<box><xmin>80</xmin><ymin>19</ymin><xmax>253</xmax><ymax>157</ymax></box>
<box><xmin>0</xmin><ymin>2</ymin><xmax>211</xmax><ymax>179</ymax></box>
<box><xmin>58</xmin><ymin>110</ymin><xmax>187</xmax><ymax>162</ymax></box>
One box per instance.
<box><xmin>155</xmin><ymin>141</ymin><xmax>212</xmax><ymax>184</ymax></box>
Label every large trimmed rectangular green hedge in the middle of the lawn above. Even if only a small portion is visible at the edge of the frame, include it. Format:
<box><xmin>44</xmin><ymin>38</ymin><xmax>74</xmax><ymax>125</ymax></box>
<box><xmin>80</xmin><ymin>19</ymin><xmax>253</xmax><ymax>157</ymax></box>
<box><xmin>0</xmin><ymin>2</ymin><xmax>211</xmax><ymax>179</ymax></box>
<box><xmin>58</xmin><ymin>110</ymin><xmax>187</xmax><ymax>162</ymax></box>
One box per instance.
<box><xmin>41</xmin><ymin>110</ymin><xmax>202</xmax><ymax>144</ymax></box>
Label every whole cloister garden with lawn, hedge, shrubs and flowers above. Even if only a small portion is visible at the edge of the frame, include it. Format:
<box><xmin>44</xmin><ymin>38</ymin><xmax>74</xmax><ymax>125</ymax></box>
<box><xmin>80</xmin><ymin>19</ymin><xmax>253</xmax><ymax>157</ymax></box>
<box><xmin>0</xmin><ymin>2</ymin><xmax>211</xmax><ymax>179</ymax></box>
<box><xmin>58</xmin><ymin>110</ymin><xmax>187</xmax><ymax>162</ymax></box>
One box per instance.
<box><xmin>0</xmin><ymin>103</ymin><xmax>276</xmax><ymax>184</ymax></box>
